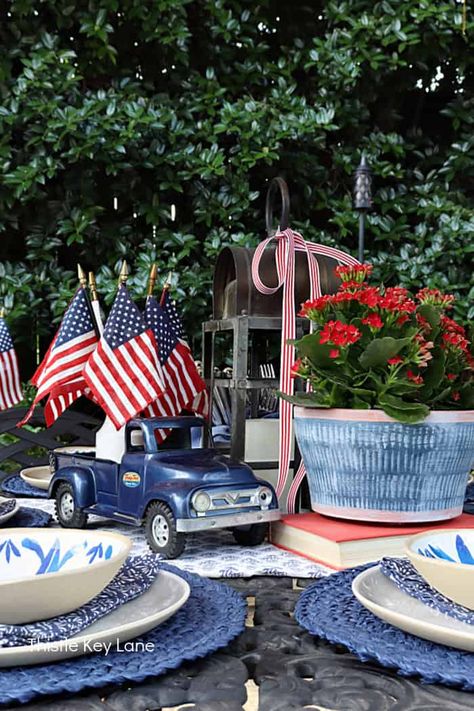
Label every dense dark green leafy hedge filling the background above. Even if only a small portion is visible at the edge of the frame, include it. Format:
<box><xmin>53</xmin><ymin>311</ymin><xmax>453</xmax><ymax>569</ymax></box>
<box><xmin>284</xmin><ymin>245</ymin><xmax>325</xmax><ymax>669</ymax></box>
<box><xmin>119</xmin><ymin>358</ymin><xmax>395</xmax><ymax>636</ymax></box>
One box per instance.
<box><xmin>0</xmin><ymin>0</ymin><xmax>474</xmax><ymax>376</ymax></box>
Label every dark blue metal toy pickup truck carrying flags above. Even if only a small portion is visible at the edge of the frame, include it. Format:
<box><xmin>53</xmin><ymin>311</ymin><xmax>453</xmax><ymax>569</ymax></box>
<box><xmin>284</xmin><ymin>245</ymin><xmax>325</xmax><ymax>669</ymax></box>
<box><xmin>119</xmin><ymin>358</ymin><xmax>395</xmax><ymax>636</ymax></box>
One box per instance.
<box><xmin>49</xmin><ymin>416</ymin><xmax>280</xmax><ymax>558</ymax></box>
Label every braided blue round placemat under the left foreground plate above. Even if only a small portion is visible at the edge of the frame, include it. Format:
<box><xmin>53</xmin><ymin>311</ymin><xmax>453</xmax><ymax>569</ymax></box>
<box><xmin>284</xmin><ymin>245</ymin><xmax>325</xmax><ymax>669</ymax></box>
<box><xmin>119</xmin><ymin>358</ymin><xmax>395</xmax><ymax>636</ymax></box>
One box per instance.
<box><xmin>0</xmin><ymin>563</ymin><xmax>246</xmax><ymax>706</ymax></box>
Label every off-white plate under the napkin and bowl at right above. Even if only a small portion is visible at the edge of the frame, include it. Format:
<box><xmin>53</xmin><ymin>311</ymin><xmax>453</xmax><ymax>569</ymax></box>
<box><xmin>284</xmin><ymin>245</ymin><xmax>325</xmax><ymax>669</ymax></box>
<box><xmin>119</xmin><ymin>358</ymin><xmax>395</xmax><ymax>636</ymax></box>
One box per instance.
<box><xmin>352</xmin><ymin>566</ymin><xmax>474</xmax><ymax>652</ymax></box>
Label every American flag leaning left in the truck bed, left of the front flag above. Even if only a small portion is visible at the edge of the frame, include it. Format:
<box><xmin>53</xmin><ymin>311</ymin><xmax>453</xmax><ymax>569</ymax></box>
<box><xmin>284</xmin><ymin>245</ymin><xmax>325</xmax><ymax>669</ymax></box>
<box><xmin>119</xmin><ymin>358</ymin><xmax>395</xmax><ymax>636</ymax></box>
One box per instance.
<box><xmin>18</xmin><ymin>287</ymin><xmax>99</xmax><ymax>427</ymax></box>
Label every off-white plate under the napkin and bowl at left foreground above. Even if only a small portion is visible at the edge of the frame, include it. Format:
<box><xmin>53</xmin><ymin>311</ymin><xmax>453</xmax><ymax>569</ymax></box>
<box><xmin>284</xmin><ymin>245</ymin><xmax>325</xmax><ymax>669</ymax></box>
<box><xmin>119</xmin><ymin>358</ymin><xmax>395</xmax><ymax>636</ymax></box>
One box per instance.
<box><xmin>0</xmin><ymin>570</ymin><xmax>190</xmax><ymax>667</ymax></box>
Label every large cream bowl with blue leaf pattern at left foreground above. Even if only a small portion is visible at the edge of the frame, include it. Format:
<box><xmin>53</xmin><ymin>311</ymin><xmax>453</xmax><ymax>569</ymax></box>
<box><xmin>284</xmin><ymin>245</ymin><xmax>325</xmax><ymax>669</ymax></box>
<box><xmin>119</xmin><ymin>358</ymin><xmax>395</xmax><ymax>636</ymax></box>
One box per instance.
<box><xmin>0</xmin><ymin>528</ymin><xmax>132</xmax><ymax>624</ymax></box>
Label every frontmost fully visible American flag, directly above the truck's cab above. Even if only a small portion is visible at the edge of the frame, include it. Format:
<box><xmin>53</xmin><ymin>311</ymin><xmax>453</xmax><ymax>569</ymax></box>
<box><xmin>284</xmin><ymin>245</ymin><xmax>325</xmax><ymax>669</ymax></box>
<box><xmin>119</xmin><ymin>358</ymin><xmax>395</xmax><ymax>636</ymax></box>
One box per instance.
<box><xmin>84</xmin><ymin>286</ymin><xmax>164</xmax><ymax>429</ymax></box>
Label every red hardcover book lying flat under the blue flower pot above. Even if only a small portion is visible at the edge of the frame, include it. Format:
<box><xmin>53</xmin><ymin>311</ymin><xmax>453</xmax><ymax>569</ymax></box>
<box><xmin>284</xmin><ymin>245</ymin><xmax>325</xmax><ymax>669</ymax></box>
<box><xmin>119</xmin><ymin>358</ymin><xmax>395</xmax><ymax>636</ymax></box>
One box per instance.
<box><xmin>270</xmin><ymin>513</ymin><xmax>474</xmax><ymax>570</ymax></box>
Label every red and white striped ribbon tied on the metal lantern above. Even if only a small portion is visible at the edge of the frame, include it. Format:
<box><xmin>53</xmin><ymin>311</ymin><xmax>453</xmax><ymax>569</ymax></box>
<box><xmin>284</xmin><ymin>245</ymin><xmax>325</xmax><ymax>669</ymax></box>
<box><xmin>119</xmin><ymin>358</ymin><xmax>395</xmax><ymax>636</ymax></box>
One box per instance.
<box><xmin>252</xmin><ymin>228</ymin><xmax>358</xmax><ymax>513</ymax></box>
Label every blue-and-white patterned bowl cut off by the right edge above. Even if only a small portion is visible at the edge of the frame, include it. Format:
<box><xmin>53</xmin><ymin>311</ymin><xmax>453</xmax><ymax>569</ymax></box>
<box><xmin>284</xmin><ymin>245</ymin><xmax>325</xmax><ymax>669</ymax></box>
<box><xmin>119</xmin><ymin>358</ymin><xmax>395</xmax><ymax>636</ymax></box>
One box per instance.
<box><xmin>405</xmin><ymin>528</ymin><xmax>474</xmax><ymax>610</ymax></box>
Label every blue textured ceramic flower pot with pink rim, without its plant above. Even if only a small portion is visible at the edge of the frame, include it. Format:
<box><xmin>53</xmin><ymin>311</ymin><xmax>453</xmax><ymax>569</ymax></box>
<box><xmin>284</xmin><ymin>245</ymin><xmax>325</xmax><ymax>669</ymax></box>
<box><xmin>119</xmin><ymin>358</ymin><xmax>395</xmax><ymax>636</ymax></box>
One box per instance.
<box><xmin>294</xmin><ymin>407</ymin><xmax>474</xmax><ymax>523</ymax></box>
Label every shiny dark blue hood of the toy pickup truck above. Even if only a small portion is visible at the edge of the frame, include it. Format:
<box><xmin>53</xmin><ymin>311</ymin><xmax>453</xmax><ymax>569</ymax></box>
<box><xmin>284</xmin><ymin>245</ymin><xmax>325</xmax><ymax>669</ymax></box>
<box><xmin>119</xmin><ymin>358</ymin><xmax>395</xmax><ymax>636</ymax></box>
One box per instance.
<box><xmin>151</xmin><ymin>449</ymin><xmax>255</xmax><ymax>485</ymax></box>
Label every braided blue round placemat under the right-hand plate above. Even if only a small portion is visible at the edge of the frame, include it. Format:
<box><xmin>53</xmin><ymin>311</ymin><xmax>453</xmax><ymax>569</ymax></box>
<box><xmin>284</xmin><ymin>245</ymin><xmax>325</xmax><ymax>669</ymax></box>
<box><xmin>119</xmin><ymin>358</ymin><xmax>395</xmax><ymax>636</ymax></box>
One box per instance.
<box><xmin>295</xmin><ymin>563</ymin><xmax>474</xmax><ymax>691</ymax></box>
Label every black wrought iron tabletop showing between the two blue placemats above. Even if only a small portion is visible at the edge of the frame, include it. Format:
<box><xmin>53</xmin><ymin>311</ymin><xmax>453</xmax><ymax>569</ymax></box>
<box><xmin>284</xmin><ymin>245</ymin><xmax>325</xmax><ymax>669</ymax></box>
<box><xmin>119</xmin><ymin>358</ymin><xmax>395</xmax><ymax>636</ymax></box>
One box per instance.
<box><xmin>10</xmin><ymin>578</ymin><xmax>474</xmax><ymax>711</ymax></box>
